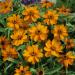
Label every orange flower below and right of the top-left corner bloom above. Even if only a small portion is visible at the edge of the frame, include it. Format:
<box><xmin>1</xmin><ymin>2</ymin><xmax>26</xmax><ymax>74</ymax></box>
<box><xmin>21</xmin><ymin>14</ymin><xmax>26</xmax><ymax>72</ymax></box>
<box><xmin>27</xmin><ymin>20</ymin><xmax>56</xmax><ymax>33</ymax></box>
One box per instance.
<box><xmin>7</xmin><ymin>14</ymin><xmax>22</xmax><ymax>29</ymax></box>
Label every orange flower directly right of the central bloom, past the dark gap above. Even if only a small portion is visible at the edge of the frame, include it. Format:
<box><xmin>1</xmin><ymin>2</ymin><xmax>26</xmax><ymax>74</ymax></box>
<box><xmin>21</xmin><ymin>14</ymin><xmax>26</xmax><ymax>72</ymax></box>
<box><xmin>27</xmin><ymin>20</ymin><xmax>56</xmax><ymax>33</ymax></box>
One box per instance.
<box><xmin>52</xmin><ymin>25</ymin><xmax>68</xmax><ymax>40</ymax></box>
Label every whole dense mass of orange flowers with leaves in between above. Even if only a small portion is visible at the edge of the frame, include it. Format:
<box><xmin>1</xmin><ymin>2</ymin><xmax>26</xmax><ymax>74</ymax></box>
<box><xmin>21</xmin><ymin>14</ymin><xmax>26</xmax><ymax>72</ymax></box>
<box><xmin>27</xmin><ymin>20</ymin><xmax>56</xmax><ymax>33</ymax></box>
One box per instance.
<box><xmin>0</xmin><ymin>0</ymin><xmax>75</xmax><ymax>75</ymax></box>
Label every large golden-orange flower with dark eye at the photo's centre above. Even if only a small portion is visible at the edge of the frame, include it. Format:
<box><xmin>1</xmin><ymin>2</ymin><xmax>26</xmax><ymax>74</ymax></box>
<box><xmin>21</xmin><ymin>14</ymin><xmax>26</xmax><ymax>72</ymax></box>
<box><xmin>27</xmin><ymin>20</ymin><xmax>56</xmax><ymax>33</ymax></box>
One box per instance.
<box><xmin>29</xmin><ymin>23</ymin><xmax>48</xmax><ymax>41</ymax></box>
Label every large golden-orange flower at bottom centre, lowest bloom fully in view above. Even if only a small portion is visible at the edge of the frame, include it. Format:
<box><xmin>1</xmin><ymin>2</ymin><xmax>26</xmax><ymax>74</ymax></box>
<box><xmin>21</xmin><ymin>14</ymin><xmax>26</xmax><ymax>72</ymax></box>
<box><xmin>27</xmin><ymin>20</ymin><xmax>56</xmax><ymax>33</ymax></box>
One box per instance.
<box><xmin>23</xmin><ymin>45</ymin><xmax>43</xmax><ymax>64</ymax></box>
